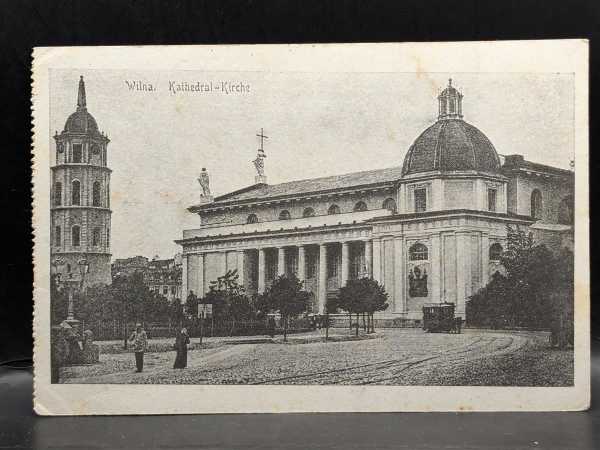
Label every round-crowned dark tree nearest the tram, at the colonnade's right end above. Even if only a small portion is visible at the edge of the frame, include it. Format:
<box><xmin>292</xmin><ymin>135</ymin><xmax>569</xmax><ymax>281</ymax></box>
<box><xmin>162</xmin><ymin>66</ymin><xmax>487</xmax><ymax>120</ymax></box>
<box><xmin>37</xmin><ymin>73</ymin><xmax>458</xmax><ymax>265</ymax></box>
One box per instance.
<box><xmin>338</xmin><ymin>277</ymin><xmax>389</xmax><ymax>336</ymax></box>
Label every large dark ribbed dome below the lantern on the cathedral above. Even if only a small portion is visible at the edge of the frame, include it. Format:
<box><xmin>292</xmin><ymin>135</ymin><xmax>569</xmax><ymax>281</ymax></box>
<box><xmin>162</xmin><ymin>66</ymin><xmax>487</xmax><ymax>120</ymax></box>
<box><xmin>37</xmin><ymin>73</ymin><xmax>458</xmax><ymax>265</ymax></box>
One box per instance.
<box><xmin>402</xmin><ymin>119</ymin><xmax>500</xmax><ymax>176</ymax></box>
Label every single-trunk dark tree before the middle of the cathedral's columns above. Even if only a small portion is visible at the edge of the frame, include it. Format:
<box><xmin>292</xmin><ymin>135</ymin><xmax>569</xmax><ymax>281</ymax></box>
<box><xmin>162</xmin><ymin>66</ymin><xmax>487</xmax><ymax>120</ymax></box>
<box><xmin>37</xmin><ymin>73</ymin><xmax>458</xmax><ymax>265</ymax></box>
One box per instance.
<box><xmin>261</xmin><ymin>274</ymin><xmax>310</xmax><ymax>341</ymax></box>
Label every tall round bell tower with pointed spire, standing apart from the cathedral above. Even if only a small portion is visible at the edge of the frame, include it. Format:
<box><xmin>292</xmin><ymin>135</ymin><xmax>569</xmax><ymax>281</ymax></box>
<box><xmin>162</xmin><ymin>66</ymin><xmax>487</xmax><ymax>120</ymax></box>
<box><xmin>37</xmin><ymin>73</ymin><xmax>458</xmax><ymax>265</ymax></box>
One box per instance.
<box><xmin>50</xmin><ymin>77</ymin><xmax>111</xmax><ymax>286</ymax></box>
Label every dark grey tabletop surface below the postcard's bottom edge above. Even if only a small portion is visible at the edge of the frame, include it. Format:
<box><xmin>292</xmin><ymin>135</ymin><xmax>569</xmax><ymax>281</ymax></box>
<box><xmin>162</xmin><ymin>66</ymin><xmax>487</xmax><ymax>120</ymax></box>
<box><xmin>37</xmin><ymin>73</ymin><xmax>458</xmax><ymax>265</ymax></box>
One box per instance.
<box><xmin>0</xmin><ymin>342</ymin><xmax>600</xmax><ymax>450</ymax></box>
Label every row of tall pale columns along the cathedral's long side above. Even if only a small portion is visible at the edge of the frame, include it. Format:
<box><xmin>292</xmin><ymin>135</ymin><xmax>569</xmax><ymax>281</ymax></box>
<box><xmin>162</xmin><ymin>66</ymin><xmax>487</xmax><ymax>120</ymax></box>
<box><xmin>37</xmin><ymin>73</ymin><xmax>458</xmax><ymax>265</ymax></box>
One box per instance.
<box><xmin>179</xmin><ymin>221</ymin><xmax>372</xmax><ymax>313</ymax></box>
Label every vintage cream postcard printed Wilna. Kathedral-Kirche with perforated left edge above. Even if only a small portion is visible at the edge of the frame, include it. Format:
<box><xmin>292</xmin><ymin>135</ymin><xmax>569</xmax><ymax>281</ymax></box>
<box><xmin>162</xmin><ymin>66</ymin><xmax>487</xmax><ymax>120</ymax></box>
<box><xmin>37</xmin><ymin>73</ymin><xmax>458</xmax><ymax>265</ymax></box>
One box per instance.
<box><xmin>32</xmin><ymin>40</ymin><xmax>590</xmax><ymax>415</ymax></box>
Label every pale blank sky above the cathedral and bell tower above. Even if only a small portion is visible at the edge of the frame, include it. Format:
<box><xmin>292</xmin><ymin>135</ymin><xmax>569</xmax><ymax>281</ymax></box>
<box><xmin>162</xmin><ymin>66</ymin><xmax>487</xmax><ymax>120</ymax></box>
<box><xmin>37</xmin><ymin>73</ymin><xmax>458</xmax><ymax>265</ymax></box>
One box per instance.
<box><xmin>48</xmin><ymin>69</ymin><xmax>574</xmax><ymax>258</ymax></box>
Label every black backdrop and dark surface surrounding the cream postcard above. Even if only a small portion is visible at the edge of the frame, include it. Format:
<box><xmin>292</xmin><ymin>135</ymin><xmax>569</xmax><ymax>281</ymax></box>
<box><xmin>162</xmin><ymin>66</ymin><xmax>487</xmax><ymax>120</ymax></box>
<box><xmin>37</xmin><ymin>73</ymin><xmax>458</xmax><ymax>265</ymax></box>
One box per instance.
<box><xmin>0</xmin><ymin>0</ymin><xmax>600</xmax><ymax>449</ymax></box>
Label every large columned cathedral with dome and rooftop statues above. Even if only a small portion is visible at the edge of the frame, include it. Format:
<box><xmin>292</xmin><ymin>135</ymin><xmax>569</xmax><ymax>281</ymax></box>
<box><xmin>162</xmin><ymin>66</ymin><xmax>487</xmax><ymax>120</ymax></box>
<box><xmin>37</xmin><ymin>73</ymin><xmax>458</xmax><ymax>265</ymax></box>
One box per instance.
<box><xmin>177</xmin><ymin>80</ymin><xmax>574</xmax><ymax>321</ymax></box>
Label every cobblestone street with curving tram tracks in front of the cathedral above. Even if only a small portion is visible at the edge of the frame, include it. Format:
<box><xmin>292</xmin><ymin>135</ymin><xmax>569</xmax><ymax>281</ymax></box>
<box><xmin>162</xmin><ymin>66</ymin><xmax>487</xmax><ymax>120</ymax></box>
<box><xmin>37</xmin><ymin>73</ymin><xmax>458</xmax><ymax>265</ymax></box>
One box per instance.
<box><xmin>61</xmin><ymin>329</ymin><xmax>573</xmax><ymax>386</ymax></box>
